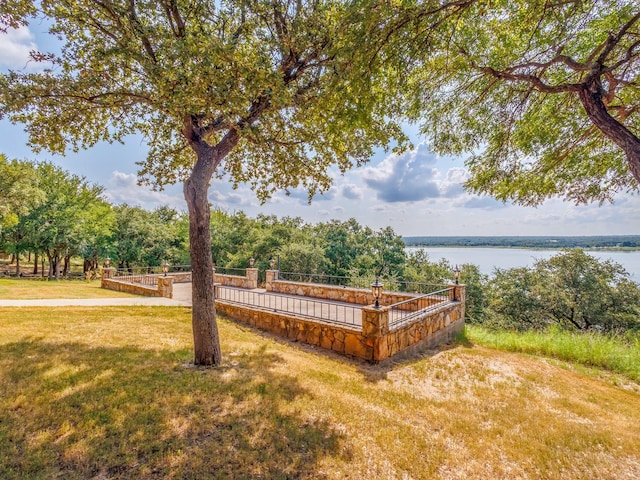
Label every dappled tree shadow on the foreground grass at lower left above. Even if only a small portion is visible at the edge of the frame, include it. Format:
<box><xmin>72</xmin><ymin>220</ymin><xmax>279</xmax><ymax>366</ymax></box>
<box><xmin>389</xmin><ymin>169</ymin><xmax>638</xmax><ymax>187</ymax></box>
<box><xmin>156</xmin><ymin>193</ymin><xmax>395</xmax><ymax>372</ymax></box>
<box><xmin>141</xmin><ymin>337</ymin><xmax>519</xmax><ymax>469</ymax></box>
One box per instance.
<box><xmin>0</xmin><ymin>340</ymin><xmax>349</xmax><ymax>480</ymax></box>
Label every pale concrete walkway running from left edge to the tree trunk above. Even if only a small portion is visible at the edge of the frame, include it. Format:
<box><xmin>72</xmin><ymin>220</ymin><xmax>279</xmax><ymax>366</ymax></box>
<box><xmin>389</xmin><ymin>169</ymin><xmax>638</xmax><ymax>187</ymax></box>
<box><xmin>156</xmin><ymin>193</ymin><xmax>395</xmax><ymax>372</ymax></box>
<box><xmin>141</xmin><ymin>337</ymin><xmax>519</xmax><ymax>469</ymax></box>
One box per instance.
<box><xmin>0</xmin><ymin>283</ymin><xmax>191</xmax><ymax>307</ymax></box>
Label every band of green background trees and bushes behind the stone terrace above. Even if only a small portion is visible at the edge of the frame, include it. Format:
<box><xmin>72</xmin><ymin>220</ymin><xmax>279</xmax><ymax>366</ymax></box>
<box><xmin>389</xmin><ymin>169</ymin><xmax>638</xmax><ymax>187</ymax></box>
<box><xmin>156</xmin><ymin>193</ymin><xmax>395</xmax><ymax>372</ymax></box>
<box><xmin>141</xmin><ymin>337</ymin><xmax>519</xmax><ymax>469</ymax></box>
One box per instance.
<box><xmin>0</xmin><ymin>155</ymin><xmax>640</xmax><ymax>332</ymax></box>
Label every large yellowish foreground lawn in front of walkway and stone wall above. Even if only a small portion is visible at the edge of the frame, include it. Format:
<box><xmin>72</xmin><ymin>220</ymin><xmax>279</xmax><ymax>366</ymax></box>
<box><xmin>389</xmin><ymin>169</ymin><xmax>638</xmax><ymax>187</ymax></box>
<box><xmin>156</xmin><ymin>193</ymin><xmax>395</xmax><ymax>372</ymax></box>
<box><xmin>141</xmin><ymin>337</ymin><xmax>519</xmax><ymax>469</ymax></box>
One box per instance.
<box><xmin>0</xmin><ymin>307</ymin><xmax>640</xmax><ymax>480</ymax></box>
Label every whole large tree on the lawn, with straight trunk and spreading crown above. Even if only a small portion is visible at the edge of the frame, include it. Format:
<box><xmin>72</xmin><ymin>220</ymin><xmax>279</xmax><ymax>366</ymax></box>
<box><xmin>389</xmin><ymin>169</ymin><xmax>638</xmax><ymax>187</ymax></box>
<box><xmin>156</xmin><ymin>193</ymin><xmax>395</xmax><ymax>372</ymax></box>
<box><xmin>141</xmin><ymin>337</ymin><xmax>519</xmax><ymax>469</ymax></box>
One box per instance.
<box><xmin>0</xmin><ymin>0</ymin><xmax>404</xmax><ymax>365</ymax></box>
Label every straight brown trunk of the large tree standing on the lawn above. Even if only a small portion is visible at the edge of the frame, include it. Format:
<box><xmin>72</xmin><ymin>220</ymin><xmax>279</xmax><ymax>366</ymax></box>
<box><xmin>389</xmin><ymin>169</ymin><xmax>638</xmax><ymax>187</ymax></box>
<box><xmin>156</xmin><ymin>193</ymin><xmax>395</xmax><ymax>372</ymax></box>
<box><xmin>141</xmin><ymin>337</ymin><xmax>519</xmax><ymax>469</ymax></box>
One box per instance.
<box><xmin>184</xmin><ymin>168</ymin><xmax>222</xmax><ymax>365</ymax></box>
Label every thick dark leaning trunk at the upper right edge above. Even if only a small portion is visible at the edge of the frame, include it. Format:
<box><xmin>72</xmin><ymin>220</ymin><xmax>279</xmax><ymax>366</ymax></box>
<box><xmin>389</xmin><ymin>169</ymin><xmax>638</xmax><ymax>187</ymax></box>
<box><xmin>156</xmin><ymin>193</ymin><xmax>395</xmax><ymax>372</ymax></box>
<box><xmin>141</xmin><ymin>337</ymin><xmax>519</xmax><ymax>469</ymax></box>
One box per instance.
<box><xmin>578</xmin><ymin>77</ymin><xmax>640</xmax><ymax>184</ymax></box>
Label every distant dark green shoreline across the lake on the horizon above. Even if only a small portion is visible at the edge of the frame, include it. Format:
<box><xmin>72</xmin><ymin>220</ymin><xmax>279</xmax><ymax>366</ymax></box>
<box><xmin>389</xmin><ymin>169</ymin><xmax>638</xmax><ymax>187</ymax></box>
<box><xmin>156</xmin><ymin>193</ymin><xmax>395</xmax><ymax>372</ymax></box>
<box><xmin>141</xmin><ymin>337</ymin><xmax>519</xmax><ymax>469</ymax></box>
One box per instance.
<box><xmin>403</xmin><ymin>235</ymin><xmax>640</xmax><ymax>252</ymax></box>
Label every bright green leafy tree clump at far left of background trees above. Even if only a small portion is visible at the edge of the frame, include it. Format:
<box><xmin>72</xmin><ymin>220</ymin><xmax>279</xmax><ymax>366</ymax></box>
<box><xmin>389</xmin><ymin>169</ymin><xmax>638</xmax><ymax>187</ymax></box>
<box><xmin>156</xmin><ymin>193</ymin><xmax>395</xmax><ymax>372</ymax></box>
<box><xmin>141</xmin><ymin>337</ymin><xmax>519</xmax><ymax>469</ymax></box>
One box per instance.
<box><xmin>0</xmin><ymin>156</ymin><xmax>112</xmax><ymax>278</ymax></box>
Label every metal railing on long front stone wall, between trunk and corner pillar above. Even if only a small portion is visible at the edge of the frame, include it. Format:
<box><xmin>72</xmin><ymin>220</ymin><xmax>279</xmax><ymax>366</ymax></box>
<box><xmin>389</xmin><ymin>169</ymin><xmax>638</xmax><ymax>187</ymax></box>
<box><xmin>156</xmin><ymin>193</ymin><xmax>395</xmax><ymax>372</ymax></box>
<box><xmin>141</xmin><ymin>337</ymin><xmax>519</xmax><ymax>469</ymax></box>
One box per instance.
<box><xmin>216</xmin><ymin>286</ymin><xmax>362</xmax><ymax>327</ymax></box>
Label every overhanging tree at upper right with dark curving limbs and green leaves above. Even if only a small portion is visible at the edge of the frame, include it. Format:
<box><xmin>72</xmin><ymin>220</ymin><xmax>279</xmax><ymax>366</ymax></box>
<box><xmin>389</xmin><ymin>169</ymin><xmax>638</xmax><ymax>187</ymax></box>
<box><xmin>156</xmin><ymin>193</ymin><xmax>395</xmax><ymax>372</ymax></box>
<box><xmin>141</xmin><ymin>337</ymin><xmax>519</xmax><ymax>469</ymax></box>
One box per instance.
<box><xmin>392</xmin><ymin>0</ymin><xmax>640</xmax><ymax>205</ymax></box>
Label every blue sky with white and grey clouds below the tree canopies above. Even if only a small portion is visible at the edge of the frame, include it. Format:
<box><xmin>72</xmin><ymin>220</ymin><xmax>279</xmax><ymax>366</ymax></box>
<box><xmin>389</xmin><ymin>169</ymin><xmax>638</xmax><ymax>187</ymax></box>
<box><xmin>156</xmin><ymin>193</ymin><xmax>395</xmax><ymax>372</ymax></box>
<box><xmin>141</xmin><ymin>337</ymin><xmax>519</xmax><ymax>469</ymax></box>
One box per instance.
<box><xmin>0</xmin><ymin>25</ymin><xmax>640</xmax><ymax>236</ymax></box>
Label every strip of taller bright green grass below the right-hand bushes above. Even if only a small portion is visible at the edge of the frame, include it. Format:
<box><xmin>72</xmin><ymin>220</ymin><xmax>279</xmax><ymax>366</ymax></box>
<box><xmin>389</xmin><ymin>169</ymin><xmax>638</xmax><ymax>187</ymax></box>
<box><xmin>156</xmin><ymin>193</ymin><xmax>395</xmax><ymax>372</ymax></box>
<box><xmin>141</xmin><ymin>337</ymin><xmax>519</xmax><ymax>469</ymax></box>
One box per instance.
<box><xmin>465</xmin><ymin>326</ymin><xmax>640</xmax><ymax>382</ymax></box>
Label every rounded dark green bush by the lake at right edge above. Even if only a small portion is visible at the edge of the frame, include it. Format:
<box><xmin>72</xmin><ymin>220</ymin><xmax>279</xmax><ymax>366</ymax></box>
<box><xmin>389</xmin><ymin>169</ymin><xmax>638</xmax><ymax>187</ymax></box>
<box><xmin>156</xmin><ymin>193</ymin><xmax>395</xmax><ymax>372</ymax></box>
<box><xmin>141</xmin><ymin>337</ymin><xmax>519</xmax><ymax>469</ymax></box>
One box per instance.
<box><xmin>487</xmin><ymin>249</ymin><xmax>640</xmax><ymax>332</ymax></box>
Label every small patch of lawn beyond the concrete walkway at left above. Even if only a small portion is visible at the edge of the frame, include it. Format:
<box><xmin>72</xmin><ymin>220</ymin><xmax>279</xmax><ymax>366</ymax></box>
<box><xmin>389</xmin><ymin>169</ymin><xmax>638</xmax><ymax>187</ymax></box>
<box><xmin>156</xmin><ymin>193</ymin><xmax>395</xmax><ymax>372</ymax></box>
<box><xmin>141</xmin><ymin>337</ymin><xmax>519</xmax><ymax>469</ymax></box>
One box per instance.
<box><xmin>0</xmin><ymin>278</ymin><xmax>135</xmax><ymax>300</ymax></box>
